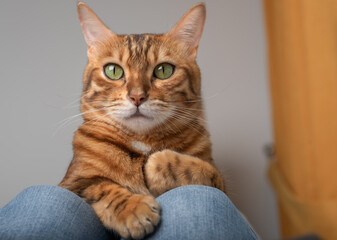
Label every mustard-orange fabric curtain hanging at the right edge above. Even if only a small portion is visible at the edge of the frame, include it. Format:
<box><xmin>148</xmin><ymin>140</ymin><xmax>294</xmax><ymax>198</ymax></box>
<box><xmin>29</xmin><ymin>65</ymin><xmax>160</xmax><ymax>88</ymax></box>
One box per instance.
<box><xmin>264</xmin><ymin>0</ymin><xmax>337</xmax><ymax>239</ymax></box>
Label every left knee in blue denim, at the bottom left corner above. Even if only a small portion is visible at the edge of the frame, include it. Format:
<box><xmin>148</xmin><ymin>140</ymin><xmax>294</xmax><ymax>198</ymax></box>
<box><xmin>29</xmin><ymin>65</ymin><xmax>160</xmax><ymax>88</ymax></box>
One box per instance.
<box><xmin>0</xmin><ymin>186</ymin><xmax>111</xmax><ymax>239</ymax></box>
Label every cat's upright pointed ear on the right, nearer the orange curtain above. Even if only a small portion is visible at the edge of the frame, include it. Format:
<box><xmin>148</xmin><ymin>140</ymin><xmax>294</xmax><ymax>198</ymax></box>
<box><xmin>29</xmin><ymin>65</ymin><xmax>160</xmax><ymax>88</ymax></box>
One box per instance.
<box><xmin>166</xmin><ymin>3</ymin><xmax>206</xmax><ymax>58</ymax></box>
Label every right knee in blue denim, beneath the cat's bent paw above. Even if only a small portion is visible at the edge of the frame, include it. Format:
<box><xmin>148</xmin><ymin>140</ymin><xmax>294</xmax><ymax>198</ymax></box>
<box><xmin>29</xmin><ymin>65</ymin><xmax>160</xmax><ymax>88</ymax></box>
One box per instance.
<box><xmin>143</xmin><ymin>185</ymin><xmax>257</xmax><ymax>240</ymax></box>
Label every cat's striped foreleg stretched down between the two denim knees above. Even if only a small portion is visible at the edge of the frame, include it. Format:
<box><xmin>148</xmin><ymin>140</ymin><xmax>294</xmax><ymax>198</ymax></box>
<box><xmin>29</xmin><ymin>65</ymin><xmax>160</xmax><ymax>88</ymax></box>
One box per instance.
<box><xmin>60</xmin><ymin>177</ymin><xmax>160</xmax><ymax>239</ymax></box>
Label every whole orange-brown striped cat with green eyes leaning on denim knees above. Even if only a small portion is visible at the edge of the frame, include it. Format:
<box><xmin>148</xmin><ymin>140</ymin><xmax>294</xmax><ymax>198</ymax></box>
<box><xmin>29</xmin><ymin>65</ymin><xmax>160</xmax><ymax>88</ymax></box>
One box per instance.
<box><xmin>59</xmin><ymin>2</ymin><xmax>225</xmax><ymax>239</ymax></box>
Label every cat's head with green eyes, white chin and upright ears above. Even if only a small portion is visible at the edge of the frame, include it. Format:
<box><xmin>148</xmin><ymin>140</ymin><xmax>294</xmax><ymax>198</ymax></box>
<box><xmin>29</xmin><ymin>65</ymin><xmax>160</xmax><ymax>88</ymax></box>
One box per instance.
<box><xmin>78</xmin><ymin>3</ymin><xmax>206</xmax><ymax>134</ymax></box>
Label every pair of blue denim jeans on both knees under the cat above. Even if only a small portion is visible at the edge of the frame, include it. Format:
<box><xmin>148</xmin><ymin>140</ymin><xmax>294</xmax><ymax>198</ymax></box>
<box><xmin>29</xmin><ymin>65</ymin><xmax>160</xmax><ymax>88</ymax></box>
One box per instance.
<box><xmin>0</xmin><ymin>185</ymin><xmax>257</xmax><ymax>240</ymax></box>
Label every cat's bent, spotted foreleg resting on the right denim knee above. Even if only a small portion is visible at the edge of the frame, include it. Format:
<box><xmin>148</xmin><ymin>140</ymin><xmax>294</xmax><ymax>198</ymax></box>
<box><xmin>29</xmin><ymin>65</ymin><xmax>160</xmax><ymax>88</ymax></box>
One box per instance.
<box><xmin>144</xmin><ymin>150</ymin><xmax>225</xmax><ymax>196</ymax></box>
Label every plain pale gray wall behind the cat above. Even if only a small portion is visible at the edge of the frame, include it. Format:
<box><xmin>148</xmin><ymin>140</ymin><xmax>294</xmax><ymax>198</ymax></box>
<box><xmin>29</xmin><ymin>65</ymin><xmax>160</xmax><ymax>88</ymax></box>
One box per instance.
<box><xmin>0</xmin><ymin>0</ymin><xmax>279</xmax><ymax>239</ymax></box>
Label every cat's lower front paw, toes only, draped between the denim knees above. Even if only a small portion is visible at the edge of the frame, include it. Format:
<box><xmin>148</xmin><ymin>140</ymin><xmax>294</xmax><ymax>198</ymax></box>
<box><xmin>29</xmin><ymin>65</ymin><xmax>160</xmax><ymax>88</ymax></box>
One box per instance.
<box><xmin>115</xmin><ymin>194</ymin><xmax>160</xmax><ymax>239</ymax></box>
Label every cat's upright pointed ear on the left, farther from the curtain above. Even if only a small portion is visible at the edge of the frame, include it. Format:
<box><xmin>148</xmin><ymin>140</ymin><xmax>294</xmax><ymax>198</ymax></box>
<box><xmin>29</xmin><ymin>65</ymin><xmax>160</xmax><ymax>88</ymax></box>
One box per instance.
<box><xmin>77</xmin><ymin>2</ymin><xmax>116</xmax><ymax>50</ymax></box>
